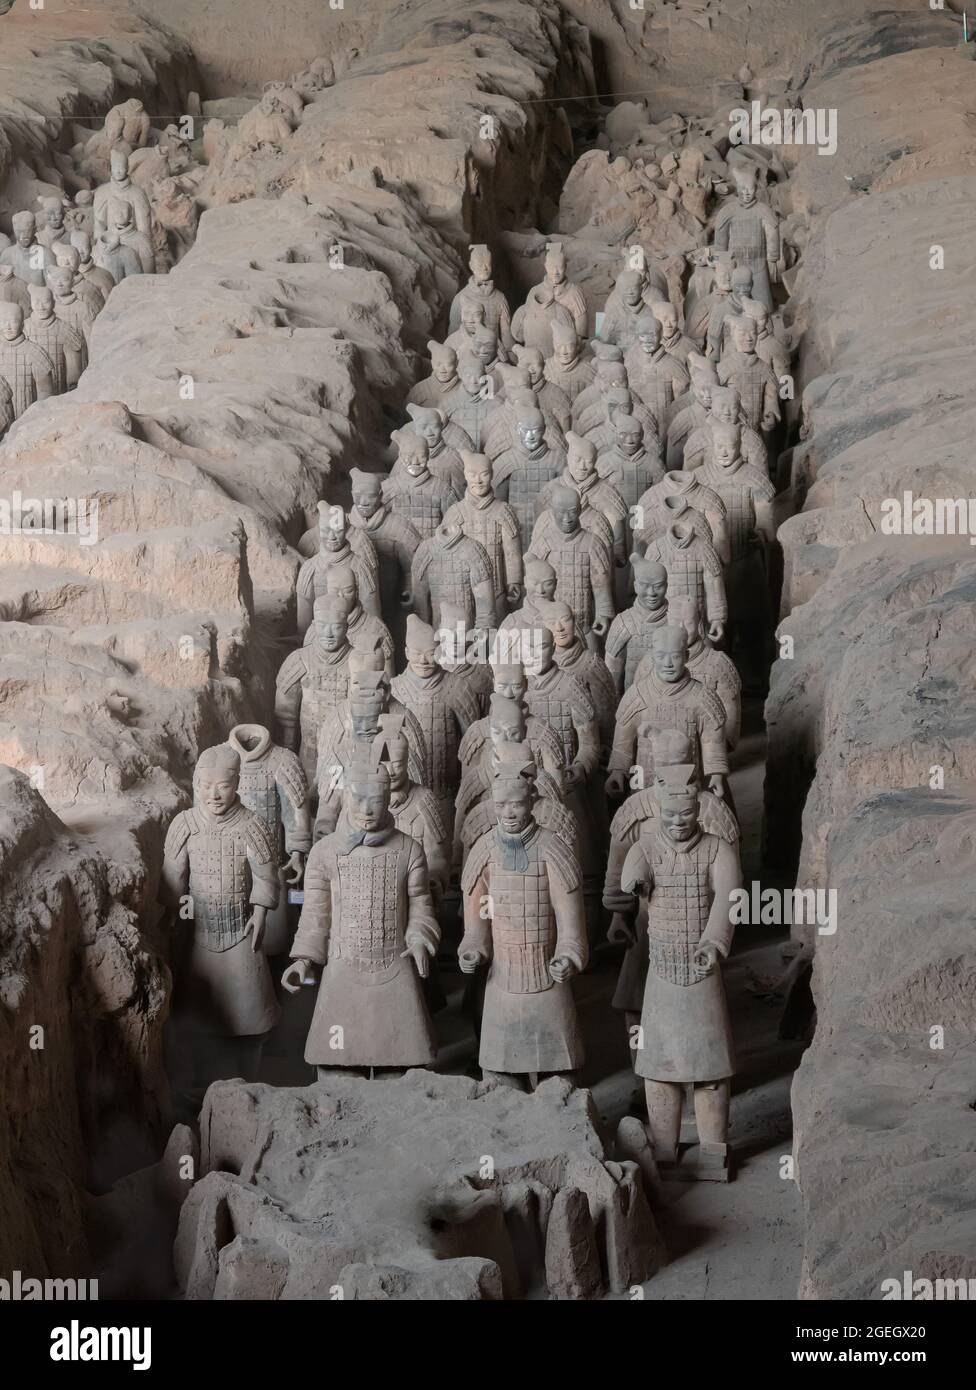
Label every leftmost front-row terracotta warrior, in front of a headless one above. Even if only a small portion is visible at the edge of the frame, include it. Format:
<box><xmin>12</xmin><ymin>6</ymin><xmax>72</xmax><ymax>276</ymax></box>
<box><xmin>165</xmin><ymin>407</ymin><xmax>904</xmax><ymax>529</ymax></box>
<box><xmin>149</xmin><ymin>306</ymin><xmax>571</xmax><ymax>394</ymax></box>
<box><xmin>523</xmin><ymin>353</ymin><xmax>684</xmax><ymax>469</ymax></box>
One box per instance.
<box><xmin>160</xmin><ymin>744</ymin><xmax>279</xmax><ymax>1095</ymax></box>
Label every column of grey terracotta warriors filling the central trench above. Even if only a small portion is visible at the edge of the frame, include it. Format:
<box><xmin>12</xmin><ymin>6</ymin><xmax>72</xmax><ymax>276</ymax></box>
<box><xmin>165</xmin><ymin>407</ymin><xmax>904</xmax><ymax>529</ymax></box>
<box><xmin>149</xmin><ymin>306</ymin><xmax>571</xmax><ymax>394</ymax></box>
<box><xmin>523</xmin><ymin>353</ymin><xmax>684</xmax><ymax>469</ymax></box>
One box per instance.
<box><xmin>155</xmin><ymin>154</ymin><xmax>790</xmax><ymax>1170</ymax></box>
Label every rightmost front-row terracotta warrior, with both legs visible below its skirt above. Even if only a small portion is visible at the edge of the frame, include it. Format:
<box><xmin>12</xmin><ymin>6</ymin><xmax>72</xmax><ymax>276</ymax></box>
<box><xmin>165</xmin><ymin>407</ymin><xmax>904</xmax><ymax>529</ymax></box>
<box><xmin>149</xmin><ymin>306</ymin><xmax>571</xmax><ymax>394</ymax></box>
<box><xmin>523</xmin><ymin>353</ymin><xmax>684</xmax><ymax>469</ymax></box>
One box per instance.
<box><xmin>620</xmin><ymin>766</ymin><xmax>742</xmax><ymax>1168</ymax></box>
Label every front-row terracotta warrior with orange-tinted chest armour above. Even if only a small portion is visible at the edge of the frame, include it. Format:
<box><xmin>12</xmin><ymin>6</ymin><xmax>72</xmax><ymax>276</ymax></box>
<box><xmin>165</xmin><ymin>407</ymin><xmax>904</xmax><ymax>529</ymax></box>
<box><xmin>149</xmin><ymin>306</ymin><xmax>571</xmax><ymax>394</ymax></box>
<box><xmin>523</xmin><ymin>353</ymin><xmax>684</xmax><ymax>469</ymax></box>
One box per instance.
<box><xmin>457</xmin><ymin>765</ymin><xmax>588</xmax><ymax>1088</ymax></box>
